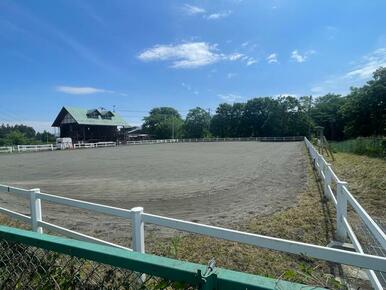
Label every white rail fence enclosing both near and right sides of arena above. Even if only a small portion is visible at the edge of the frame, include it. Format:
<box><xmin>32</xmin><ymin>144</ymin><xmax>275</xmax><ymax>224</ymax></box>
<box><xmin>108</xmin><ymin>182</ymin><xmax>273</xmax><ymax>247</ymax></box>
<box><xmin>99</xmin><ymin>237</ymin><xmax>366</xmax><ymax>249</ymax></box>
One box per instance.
<box><xmin>0</xmin><ymin>139</ymin><xmax>386</xmax><ymax>289</ymax></box>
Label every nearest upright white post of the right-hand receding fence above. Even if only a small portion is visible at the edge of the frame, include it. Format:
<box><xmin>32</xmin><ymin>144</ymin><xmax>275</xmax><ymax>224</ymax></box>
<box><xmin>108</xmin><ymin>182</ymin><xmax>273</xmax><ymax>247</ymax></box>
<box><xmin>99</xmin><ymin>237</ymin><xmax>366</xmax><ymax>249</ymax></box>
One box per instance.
<box><xmin>336</xmin><ymin>181</ymin><xmax>347</xmax><ymax>242</ymax></box>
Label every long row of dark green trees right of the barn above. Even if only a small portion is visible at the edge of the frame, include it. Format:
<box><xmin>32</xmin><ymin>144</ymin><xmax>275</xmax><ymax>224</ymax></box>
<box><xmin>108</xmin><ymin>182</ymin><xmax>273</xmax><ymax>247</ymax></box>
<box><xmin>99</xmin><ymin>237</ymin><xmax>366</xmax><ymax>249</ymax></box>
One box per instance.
<box><xmin>142</xmin><ymin>68</ymin><xmax>386</xmax><ymax>141</ymax></box>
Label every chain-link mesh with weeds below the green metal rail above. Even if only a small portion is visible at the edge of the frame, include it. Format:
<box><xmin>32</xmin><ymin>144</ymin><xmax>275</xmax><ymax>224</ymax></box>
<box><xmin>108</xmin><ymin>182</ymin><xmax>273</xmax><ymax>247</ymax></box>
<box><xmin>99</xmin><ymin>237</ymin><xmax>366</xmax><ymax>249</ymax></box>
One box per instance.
<box><xmin>0</xmin><ymin>240</ymin><xmax>198</xmax><ymax>289</ymax></box>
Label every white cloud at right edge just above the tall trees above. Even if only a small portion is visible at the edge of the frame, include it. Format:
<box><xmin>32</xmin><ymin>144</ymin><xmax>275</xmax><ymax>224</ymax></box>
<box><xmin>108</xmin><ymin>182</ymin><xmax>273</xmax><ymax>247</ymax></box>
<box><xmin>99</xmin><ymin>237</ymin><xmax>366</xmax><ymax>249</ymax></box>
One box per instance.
<box><xmin>345</xmin><ymin>48</ymin><xmax>386</xmax><ymax>80</ymax></box>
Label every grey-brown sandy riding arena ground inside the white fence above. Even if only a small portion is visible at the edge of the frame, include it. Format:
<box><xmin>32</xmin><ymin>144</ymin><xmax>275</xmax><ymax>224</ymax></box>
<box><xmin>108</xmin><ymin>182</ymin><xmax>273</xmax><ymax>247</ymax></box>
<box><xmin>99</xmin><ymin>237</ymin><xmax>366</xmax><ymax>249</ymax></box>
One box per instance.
<box><xmin>0</xmin><ymin>142</ymin><xmax>307</xmax><ymax>245</ymax></box>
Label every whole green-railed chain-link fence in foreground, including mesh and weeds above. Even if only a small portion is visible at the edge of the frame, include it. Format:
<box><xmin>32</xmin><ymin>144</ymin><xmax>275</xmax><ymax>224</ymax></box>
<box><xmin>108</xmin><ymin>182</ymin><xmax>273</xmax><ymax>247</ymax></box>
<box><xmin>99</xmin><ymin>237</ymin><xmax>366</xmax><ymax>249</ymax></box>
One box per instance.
<box><xmin>0</xmin><ymin>226</ymin><xmax>322</xmax><ymax>290</ymax></box>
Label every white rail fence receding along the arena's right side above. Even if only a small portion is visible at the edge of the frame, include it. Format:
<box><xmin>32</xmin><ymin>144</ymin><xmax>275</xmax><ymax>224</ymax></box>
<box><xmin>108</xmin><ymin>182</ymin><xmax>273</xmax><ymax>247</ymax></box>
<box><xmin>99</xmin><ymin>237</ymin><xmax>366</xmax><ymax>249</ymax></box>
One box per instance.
<box><xmin>305</xmin><ymin>138</ymin><xmax>386</xmax><ymax>289</ymax></box>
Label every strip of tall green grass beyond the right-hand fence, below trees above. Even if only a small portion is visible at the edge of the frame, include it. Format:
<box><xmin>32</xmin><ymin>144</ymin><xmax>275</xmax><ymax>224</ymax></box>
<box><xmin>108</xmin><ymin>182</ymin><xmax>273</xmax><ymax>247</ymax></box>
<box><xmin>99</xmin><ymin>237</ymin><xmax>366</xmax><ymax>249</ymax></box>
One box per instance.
<box><xmin>331</xmin><ymin>138</ymin><xmax>386</xmax><ymax>158</ymax></box>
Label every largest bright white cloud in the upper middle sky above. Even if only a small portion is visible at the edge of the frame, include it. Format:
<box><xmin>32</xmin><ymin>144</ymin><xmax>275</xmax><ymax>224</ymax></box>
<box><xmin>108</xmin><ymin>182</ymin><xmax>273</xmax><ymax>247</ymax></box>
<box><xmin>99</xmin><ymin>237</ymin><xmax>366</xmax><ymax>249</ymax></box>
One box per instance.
<box><xmin>138</xmin><ymin>42</ymin><xmax>247</xmax><ymax>68</ymax></box>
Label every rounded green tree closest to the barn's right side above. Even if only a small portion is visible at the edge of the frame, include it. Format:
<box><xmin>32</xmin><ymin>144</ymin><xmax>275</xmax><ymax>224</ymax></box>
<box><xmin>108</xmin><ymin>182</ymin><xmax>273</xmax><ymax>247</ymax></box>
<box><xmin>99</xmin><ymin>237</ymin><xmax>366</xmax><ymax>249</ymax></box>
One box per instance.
<box><xmin>143</xmin><ymin>107</ymin><xmax>183</xmax><ymax>139</ymax></box>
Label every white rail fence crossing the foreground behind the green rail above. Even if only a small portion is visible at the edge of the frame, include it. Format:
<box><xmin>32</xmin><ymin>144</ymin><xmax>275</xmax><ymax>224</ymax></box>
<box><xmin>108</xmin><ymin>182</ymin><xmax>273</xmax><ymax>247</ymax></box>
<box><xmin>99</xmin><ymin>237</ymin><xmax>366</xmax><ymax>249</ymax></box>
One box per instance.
<box><xmin>0</xmin><ymin>181</ymin><xmax>386</xmax><ymax>271</ymax></box>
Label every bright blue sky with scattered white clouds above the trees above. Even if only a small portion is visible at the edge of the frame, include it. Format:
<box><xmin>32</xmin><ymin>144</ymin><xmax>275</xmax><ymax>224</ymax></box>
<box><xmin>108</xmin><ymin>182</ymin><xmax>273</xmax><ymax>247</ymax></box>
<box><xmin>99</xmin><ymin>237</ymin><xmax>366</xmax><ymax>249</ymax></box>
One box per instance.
<box><xmin>0</xmin><ymin>0</ymin><xmax>386</xmax><ymax>130</ymax></box>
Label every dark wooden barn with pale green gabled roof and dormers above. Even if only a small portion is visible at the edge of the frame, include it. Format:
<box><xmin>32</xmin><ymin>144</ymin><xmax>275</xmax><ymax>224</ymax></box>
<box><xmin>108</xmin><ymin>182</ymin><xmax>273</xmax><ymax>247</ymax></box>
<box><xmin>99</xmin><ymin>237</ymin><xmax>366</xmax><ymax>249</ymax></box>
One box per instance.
<box><xmin>52</xmin><ymin>107</ymin><xmax>129</xmax><ymax>142</ymax></box>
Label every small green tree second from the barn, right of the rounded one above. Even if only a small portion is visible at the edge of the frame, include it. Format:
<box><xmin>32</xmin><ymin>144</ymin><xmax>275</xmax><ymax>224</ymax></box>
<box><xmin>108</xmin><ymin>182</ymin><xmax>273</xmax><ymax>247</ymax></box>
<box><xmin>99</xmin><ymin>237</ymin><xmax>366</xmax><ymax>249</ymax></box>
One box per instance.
<box><xmin>184</xmin><ymin>107</ymin><xmax>210</xmax><ymax>138</ymax></box>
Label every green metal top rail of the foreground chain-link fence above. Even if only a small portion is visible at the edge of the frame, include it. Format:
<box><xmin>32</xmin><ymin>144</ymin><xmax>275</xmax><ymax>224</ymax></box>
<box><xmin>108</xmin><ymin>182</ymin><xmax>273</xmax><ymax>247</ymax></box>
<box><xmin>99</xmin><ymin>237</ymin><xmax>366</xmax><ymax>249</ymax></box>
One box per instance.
<box><xmin>0</xmin><ymin>225</ymin><xmax>323</xmax><ymax>290</ymax></box>
